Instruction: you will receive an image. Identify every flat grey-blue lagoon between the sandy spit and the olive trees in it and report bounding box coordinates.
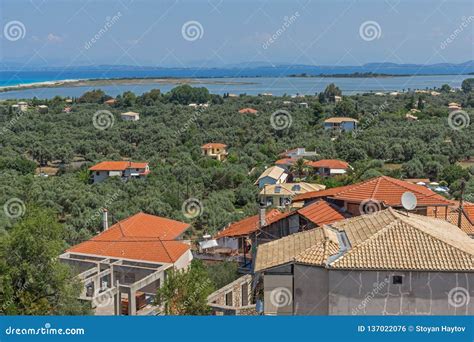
[0,75,472,99]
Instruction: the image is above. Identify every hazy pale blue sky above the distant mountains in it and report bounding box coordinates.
[0,0,474,67]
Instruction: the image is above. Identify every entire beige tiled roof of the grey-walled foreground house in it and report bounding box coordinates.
[255,208,474,272]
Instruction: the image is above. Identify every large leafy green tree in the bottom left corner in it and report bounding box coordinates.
[0,207,90,315]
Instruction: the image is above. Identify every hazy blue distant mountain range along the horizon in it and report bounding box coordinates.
[0,60,474,77]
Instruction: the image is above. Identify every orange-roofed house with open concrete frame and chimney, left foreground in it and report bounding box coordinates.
[60,210,192,315]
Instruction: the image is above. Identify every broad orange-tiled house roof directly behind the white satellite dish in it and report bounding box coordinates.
[293,176,452,218]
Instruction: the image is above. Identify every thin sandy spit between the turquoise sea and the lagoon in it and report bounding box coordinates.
[0,77,256,93]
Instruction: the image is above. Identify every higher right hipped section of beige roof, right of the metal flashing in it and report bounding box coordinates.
[330,208,474,271]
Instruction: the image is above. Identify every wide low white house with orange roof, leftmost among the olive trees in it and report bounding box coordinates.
[89,161,150,184]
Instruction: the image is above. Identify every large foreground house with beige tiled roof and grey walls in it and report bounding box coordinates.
[253,208,474,316]
